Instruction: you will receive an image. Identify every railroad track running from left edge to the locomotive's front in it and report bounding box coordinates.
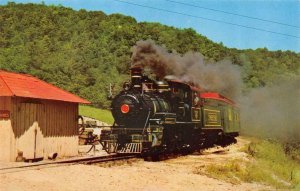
[0,155,137,174]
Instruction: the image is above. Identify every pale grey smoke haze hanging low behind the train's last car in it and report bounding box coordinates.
[240,77,300,142]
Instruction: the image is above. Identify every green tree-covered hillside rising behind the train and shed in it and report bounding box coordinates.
[0,3,300,108]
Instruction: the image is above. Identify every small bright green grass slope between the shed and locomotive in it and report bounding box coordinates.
[79,105,114,124]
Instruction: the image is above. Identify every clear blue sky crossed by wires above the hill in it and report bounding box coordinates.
[0,0,300,53]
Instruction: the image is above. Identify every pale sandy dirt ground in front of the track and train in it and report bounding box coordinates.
[0,138,273,191]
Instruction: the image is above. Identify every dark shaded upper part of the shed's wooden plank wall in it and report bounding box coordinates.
[12,98,78,137]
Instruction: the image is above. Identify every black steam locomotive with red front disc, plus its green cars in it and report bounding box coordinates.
[100,67,240,157]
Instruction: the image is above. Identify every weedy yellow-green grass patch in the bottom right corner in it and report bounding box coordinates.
[198,140,300,190]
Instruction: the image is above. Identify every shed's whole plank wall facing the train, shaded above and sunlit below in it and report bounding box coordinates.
[0,97,78,161]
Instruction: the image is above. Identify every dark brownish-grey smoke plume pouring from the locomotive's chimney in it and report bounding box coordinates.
[132,40,242,98]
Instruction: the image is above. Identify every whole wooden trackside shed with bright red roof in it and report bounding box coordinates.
[0,70,90,162]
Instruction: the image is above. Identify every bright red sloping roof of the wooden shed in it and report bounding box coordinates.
[0,70,90,104]
